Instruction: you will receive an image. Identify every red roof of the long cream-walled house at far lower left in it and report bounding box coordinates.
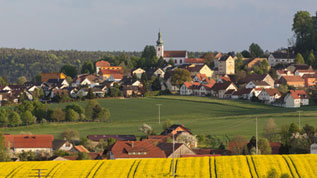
[4,135,54,149]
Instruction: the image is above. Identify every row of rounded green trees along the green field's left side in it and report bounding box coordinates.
[0,100,111,127]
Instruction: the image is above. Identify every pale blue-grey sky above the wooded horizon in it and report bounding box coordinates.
[0,0,317,52]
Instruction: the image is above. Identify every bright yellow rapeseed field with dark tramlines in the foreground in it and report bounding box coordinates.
[0,154,317,178]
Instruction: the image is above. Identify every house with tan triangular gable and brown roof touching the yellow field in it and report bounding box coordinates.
[157,143,196,158]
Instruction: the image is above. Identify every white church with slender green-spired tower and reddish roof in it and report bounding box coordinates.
[156,32,188,65]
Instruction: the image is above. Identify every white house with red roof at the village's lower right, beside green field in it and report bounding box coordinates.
[284,90,309,108]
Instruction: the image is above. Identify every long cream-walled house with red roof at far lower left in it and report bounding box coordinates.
[4,134,54,154]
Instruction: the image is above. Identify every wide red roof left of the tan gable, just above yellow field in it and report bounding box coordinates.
[111,141,166,158]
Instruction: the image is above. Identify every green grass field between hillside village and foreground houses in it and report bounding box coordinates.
[0,96,317,137]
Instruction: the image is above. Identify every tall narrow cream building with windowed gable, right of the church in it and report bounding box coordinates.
[217,55,235,75]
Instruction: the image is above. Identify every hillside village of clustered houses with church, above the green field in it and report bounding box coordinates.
[0,33,317,108]
